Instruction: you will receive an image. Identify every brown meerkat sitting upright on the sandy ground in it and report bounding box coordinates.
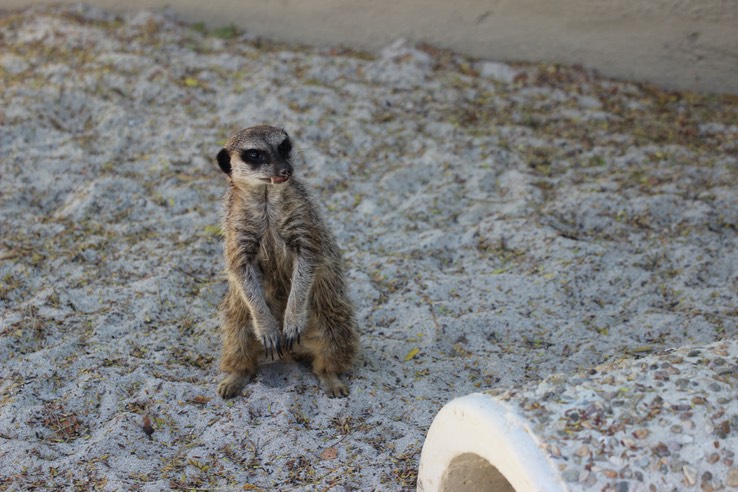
[217,125,358,398]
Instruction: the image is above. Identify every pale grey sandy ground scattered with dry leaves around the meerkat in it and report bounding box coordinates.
[0,7,738,491]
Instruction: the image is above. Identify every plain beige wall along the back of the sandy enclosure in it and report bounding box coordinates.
[0,0,738,94]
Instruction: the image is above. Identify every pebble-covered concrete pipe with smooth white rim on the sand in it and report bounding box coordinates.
[418,340,738,492]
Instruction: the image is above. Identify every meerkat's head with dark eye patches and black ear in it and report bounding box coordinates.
[217,125,292,185]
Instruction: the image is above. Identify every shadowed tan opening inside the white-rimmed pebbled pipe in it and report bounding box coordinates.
[441,453,515,492]
